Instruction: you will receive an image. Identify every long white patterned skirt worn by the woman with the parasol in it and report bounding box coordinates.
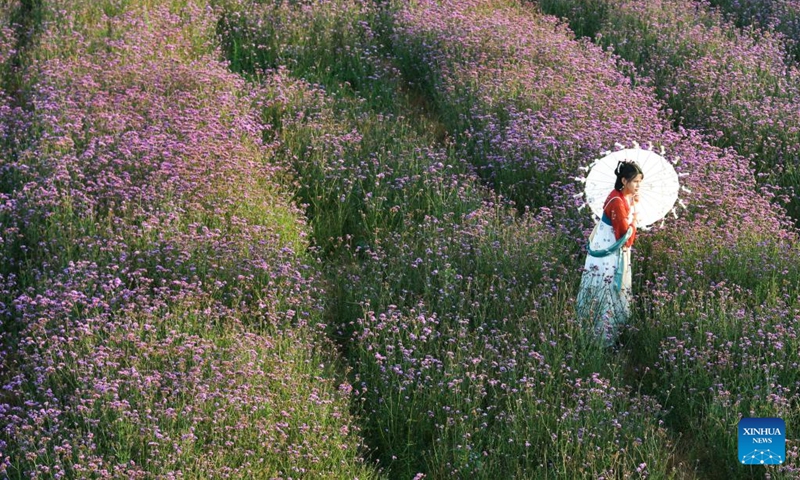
[576,221,631,346]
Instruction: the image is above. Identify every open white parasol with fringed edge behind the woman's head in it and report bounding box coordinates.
[579,144,688,228]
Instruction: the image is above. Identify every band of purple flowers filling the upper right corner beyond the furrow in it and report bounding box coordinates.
[538,0,800,219]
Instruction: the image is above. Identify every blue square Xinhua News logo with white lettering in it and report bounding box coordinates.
[739,418,786,465]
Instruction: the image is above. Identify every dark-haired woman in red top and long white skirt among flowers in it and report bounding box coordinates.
[576,161,644,346]
